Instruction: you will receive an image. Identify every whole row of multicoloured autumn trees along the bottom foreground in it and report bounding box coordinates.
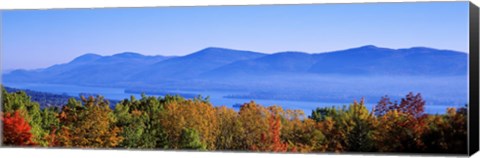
[1,88,467,154]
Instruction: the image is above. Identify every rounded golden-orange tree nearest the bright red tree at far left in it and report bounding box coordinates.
[57,96,123,148]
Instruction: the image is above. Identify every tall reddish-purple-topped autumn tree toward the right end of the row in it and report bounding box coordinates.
[375,92,428,152]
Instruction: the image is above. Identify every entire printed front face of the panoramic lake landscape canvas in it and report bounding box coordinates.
[0,2,469,154]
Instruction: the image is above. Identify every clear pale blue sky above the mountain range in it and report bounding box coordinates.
[1,2,468,70]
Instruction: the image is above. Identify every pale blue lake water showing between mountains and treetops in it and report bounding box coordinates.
[3,83,462,115]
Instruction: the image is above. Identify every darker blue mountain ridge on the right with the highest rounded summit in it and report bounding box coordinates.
[206,45,468,76]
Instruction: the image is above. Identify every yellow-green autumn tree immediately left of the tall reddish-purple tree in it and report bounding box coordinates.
[313,99,375,152]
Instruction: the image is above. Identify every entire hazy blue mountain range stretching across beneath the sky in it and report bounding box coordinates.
[3,45,468,86]
